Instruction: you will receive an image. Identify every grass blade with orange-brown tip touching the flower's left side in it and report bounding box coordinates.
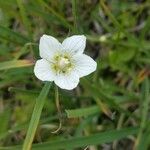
[0,59,33,70]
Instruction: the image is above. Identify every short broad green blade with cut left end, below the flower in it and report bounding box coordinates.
[66,106,100,118]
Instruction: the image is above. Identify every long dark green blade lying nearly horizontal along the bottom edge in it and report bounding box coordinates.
[0,128,138,150]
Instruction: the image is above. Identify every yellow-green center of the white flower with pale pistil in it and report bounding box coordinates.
[52,54,73,73]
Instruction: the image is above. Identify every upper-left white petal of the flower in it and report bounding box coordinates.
[39,34,61,61]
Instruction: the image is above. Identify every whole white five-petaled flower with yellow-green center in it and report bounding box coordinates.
[34,35,97,90]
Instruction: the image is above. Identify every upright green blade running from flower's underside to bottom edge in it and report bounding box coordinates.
[23,82,51,150]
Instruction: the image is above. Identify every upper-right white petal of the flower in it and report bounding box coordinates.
[62,35,86,54]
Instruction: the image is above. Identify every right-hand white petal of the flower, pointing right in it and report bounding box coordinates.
[74,54,97,77]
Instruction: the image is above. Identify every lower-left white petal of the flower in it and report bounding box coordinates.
[34,59,55,81]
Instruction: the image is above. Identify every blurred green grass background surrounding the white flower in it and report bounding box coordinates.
[0,0,150,150]
